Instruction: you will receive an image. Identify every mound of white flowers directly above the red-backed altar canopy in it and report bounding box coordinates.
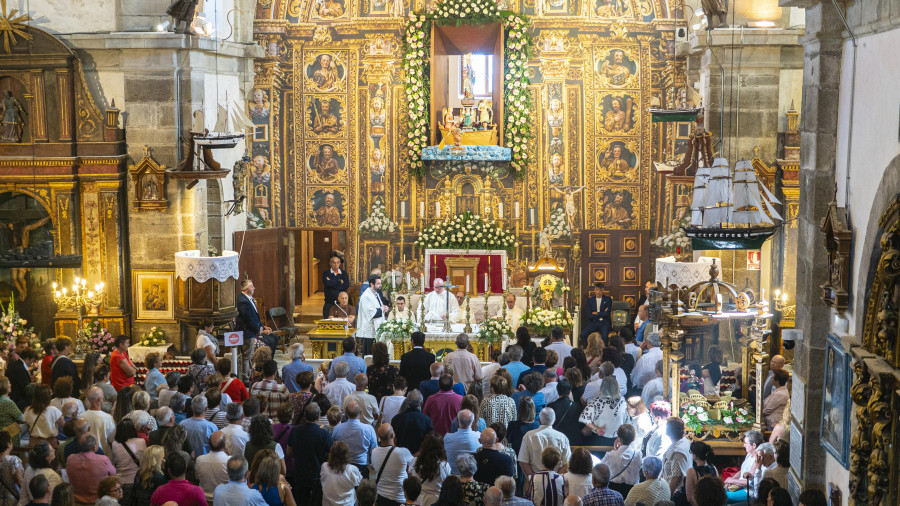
[415,213,519,251]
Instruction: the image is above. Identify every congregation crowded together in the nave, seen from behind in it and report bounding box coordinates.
[0,320,825,506]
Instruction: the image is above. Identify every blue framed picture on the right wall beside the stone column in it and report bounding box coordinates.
[820,334,851,469]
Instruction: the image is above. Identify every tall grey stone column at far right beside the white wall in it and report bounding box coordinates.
[790,2,844,500]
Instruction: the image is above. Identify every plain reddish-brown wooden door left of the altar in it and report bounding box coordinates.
[234,227,294,319]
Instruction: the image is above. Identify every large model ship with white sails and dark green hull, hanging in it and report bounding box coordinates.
[683,158,783,250]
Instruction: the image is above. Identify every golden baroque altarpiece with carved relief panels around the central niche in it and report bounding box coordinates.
[248,0,684,284]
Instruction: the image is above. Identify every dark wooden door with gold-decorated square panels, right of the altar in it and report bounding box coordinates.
[581,230,653,309]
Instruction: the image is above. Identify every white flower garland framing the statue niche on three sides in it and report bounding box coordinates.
[402,0,532,176]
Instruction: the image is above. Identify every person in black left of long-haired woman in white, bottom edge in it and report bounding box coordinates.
[287,402,332,506]
